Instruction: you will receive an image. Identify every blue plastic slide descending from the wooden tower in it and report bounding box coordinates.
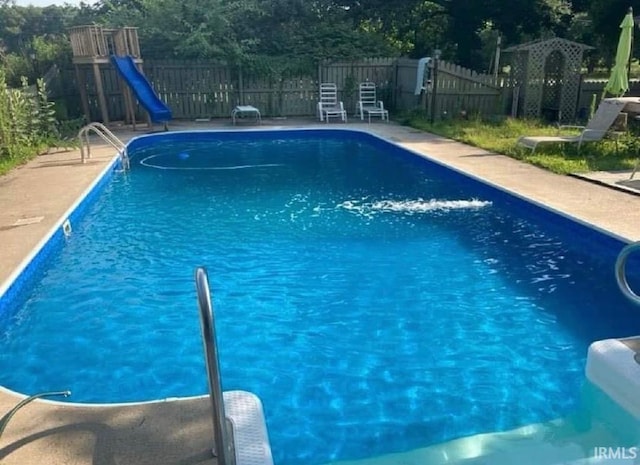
[111,55,172,123]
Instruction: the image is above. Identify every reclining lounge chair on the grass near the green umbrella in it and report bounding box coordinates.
[517,98,627,153]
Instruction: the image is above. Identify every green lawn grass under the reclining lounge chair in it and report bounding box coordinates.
[403,113,640,174]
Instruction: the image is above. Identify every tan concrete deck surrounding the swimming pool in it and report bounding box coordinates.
[0,119,640,465]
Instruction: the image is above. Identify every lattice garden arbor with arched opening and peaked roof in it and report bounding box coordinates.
[504,37,593,123]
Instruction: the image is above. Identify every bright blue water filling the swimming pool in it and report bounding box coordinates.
[0,131,640,465]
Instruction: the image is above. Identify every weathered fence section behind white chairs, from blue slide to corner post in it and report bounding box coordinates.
[149,58,394,119]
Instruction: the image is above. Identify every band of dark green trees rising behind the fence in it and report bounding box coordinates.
[0,0,640,79]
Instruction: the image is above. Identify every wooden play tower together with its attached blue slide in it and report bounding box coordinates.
[69,25,171,130]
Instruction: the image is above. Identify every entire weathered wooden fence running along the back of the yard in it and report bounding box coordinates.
[53,58,624,121]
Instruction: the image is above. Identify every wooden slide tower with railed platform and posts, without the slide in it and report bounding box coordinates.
[69,25,142,124]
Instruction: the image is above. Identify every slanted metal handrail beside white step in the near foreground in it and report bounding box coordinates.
[195,267,235,465]
